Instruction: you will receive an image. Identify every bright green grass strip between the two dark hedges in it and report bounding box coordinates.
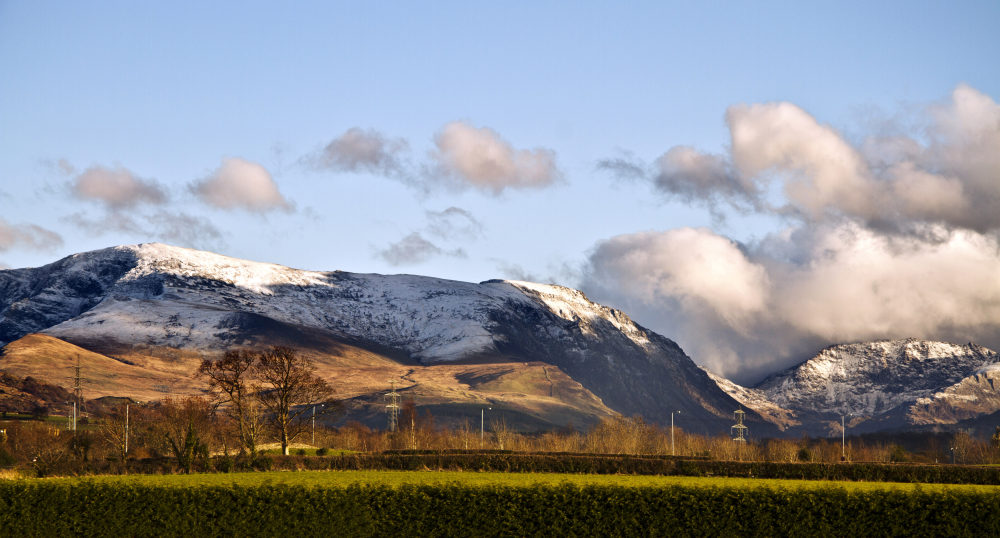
[25,471,1000,493]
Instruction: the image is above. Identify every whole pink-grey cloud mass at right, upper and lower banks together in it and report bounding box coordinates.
[583,85,1000,381]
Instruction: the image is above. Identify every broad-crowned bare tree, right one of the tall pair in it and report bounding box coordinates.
[253,347,334,456]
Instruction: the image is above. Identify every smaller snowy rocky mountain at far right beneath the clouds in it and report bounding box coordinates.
[719,339,1000,432]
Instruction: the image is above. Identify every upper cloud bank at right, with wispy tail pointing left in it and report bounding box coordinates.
[598,85,1000,232]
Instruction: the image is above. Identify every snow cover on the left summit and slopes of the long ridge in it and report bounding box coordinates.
[5,244,529,361]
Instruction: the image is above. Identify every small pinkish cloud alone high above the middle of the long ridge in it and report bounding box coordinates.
[431,122,562,194]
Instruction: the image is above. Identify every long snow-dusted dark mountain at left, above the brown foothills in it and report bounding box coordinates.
[0,244,752,432]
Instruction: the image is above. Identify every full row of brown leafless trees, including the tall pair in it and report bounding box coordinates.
[0,347,1000,474]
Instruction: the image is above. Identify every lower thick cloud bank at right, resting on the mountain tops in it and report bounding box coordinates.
[583,223,1000,382]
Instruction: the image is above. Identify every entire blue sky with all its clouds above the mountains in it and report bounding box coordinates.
[0,0,1000,383]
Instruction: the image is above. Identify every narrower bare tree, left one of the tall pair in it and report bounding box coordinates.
[198,349,264,456]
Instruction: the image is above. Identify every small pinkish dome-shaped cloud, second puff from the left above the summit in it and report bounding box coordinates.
[191,157,292,213]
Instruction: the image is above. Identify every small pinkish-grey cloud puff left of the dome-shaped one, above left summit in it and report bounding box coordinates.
[71,163,167,210]
